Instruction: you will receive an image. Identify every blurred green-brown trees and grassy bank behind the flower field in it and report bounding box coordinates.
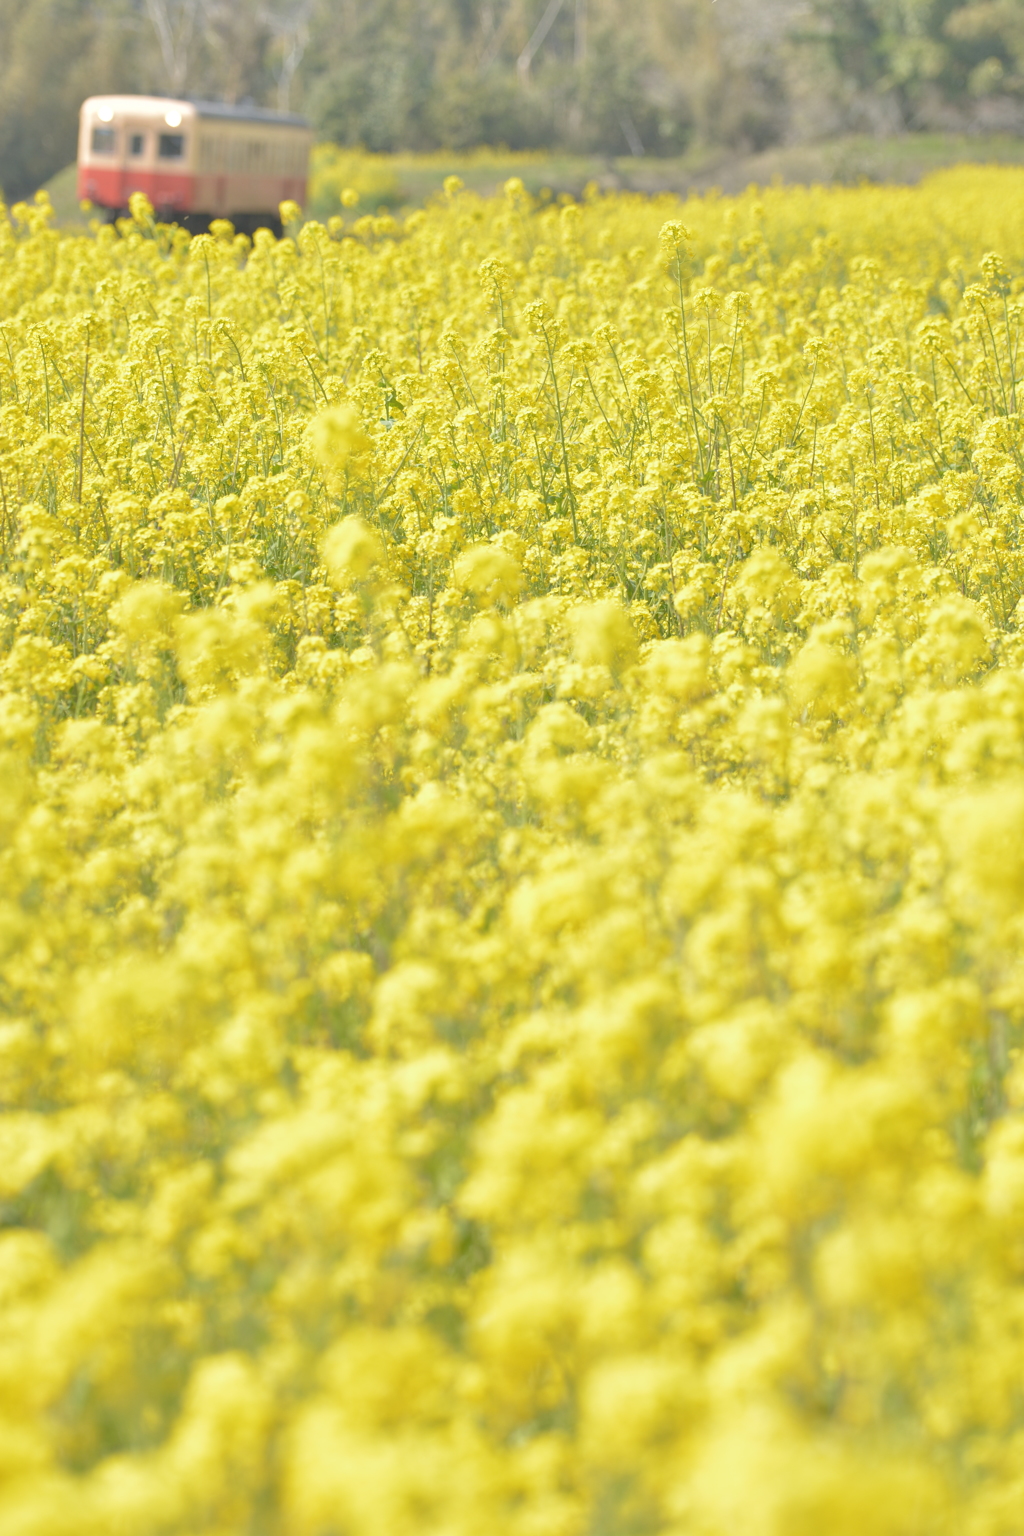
[8,0,1024,201]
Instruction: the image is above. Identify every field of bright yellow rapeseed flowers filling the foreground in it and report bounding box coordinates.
[0,169,1024,1536]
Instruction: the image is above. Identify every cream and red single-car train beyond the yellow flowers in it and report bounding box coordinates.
[78,95,313,233]
